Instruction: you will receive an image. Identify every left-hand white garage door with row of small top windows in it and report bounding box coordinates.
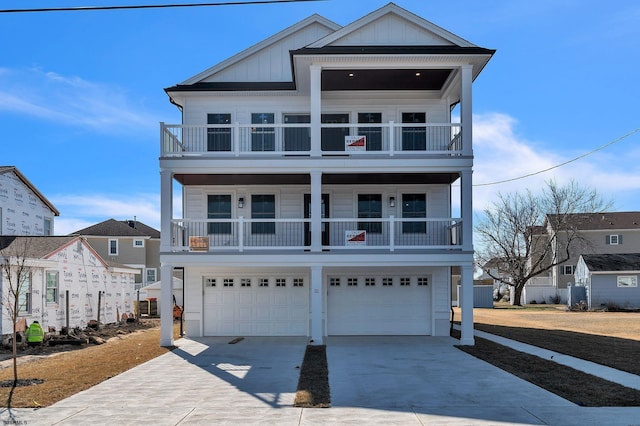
[204,277,309,336]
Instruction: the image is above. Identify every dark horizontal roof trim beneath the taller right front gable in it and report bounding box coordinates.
[291,46,496,55]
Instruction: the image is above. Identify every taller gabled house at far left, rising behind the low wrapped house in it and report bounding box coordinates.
[0,166,60,235]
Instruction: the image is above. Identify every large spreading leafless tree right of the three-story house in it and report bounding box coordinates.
[475,181,611,305]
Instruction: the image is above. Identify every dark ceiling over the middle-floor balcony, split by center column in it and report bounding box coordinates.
[174,173,460,186]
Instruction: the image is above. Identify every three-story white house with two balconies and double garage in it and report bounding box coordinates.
[160,3,494,345]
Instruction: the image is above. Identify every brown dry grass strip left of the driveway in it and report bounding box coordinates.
[0,327,177,408]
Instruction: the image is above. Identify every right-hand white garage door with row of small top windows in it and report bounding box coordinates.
[327,276,431,335]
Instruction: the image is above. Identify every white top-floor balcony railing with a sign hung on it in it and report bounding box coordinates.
[160,122,463,157]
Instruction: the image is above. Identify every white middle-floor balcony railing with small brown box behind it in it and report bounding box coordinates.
[171,216,462,252]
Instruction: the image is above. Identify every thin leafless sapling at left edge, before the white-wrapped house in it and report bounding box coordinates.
[0,236,33,386]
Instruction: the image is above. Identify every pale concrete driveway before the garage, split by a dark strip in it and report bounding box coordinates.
[0,337,640,426]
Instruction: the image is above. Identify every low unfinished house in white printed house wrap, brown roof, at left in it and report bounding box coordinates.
[0,236,139,335]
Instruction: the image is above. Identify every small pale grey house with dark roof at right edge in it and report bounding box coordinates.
[575,253,640,308]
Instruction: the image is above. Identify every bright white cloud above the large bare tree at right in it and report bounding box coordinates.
[473,113,640,211]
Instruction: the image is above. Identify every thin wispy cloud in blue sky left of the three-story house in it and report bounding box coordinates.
[0,68,161,133]
